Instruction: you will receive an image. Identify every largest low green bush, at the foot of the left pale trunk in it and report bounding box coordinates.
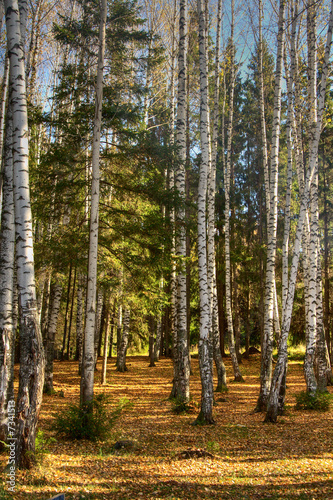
[55,394,129,441]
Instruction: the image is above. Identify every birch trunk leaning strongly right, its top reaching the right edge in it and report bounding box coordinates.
[265,1,333,422]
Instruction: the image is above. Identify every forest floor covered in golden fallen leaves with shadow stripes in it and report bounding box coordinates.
[0,355,333,500]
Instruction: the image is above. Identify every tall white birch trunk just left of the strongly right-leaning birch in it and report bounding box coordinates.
[256,0,285,411]
